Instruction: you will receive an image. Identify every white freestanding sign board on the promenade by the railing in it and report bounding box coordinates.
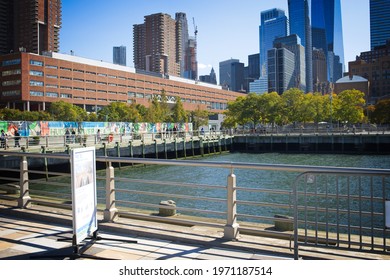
[71,147,97,245]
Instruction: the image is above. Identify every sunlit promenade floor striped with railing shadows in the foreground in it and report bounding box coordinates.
[0,201,390,260]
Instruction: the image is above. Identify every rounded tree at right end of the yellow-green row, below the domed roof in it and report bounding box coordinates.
[334,89,366,123]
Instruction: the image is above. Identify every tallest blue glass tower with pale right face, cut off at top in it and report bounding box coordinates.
[311,0,344,83]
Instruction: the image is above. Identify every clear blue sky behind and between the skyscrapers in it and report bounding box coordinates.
[60,0,370,79]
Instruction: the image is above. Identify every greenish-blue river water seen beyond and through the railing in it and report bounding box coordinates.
[34,153,390,230]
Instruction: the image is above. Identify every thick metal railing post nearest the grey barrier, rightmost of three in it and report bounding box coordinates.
[223,170,239,240]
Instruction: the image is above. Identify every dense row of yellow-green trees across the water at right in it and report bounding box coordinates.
[223,88,390,127]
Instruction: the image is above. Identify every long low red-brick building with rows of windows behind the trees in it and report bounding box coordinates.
[0,52,242,113]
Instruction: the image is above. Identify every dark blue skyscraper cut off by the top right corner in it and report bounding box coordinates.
[370,0,390,50]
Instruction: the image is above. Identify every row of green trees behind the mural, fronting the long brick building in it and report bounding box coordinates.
[0,91,209,129]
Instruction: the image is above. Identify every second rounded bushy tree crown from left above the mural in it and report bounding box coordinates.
[98,102,140,122]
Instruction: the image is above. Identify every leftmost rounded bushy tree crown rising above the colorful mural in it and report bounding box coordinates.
[49,101,88,122]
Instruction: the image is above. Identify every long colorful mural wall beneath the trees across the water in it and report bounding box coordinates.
[0,121,192,136]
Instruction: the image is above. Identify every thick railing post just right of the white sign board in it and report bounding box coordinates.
[104,162,118,222]
